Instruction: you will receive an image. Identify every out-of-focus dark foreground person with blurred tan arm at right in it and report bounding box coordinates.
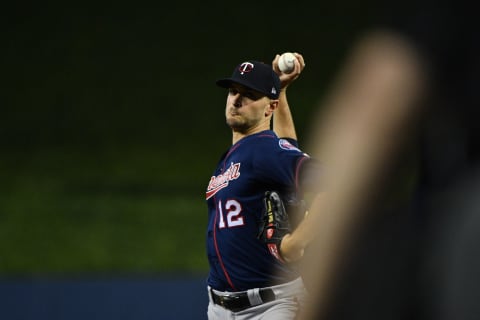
[299,1,480,320]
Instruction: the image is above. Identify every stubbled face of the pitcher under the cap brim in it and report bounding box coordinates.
[225,84,274,133]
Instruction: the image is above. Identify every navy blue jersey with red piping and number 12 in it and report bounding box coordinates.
[206,130,309,291]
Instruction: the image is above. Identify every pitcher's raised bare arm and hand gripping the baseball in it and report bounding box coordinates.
[272,52,305,140]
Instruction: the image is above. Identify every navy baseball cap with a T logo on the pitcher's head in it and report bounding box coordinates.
[216,61,280,99]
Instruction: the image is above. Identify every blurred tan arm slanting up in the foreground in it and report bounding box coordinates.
[300,32,424,319]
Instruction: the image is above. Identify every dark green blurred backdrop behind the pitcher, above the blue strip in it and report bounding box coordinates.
[0,1,378,276]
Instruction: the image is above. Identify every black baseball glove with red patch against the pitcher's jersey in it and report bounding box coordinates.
[257,191,291,262]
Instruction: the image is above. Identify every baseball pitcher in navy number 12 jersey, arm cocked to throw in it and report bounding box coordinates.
[206,53,312,320]
